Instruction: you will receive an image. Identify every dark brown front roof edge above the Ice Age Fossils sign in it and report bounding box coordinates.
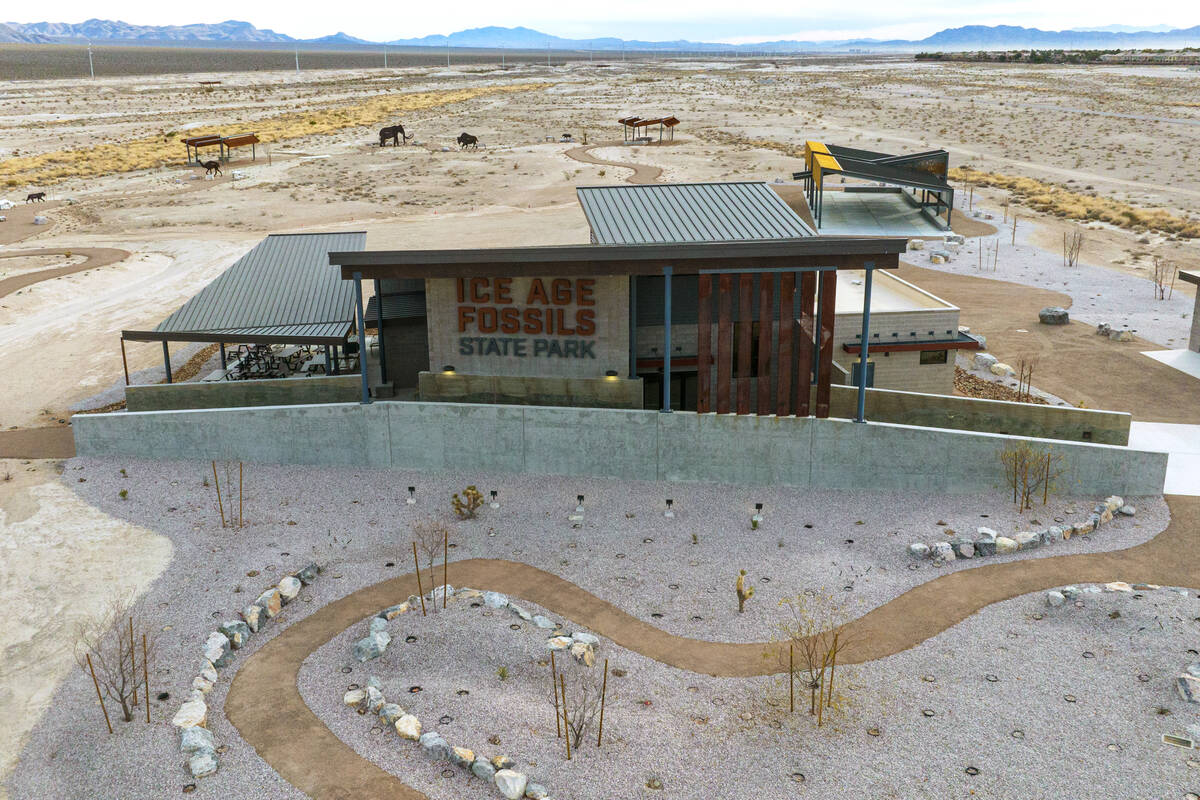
[329,236,908,279]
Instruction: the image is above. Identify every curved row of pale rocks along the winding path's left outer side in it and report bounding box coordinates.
[170,564,322,778]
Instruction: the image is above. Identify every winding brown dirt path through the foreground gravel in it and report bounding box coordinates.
[224,497,1200,800]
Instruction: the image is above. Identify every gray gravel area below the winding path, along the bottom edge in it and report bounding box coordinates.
[299,589,1200,800]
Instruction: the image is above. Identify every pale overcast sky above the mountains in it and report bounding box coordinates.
[11,0,1200,43]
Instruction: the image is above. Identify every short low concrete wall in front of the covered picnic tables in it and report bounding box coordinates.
[125,373,362,411]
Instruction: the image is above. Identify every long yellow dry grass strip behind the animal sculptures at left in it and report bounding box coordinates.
[0,83,552,186]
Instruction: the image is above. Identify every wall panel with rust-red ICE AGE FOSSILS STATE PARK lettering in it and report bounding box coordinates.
[427,277,629,377]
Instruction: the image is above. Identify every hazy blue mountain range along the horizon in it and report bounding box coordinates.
[0,19,1200,53]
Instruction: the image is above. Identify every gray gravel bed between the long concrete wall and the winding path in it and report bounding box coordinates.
[10,459,1171,800]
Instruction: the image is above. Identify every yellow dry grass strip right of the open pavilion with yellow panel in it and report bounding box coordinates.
[950,166,1200,239]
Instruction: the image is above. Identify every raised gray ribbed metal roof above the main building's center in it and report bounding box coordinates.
[575,181,815,245]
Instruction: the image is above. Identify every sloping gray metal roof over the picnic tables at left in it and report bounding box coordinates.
[122,233,366,343]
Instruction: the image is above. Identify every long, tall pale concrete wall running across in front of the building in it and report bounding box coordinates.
[72,402,1166,495]
